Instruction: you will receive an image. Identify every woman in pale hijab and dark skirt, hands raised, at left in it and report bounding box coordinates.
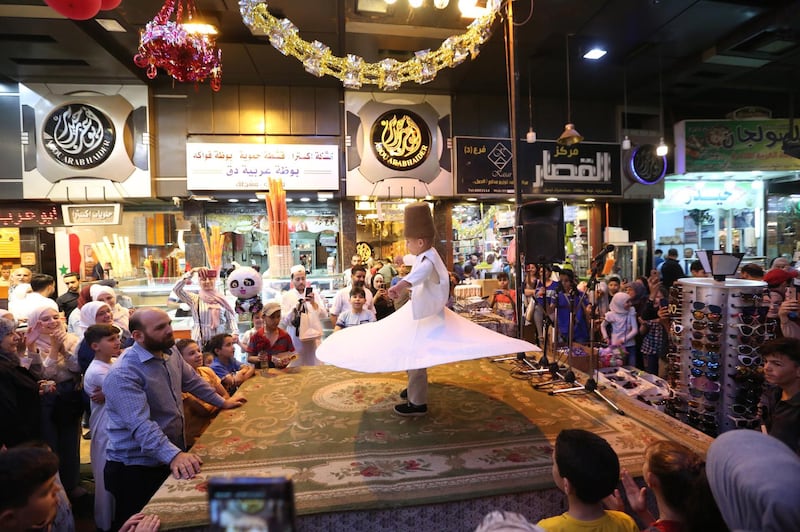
[25,306,83,498]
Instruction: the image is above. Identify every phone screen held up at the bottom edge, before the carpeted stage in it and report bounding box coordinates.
[208,477,296,532]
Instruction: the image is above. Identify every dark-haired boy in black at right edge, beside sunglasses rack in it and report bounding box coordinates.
[760,338,800,453]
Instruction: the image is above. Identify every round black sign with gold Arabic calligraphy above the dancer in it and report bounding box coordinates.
[370,109,431,170]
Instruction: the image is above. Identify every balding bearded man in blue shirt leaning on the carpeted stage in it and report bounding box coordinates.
[103,308,246,530]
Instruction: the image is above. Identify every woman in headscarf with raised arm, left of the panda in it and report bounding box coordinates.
[172,267,239,345]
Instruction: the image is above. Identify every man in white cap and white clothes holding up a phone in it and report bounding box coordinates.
[280,264,328,367]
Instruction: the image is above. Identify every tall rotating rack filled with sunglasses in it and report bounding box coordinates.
[673,278,768,436]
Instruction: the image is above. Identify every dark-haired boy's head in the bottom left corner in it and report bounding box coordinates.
[0,447,61,532]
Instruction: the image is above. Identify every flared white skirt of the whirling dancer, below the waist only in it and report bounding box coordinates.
[317,303,539,373]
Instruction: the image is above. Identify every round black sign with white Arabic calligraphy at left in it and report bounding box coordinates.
[42,103,116,170]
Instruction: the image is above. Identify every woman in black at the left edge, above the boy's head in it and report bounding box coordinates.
[0,317,43,448]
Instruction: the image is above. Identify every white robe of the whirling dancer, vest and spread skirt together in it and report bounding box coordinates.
[317,249,539,373]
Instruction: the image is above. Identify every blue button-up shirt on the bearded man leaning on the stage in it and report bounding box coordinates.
[103,343,225,467]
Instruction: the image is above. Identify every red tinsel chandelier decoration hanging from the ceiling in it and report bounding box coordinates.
[133,0,222,91]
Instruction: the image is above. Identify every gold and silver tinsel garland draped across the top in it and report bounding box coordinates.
[239,0,501,91]
